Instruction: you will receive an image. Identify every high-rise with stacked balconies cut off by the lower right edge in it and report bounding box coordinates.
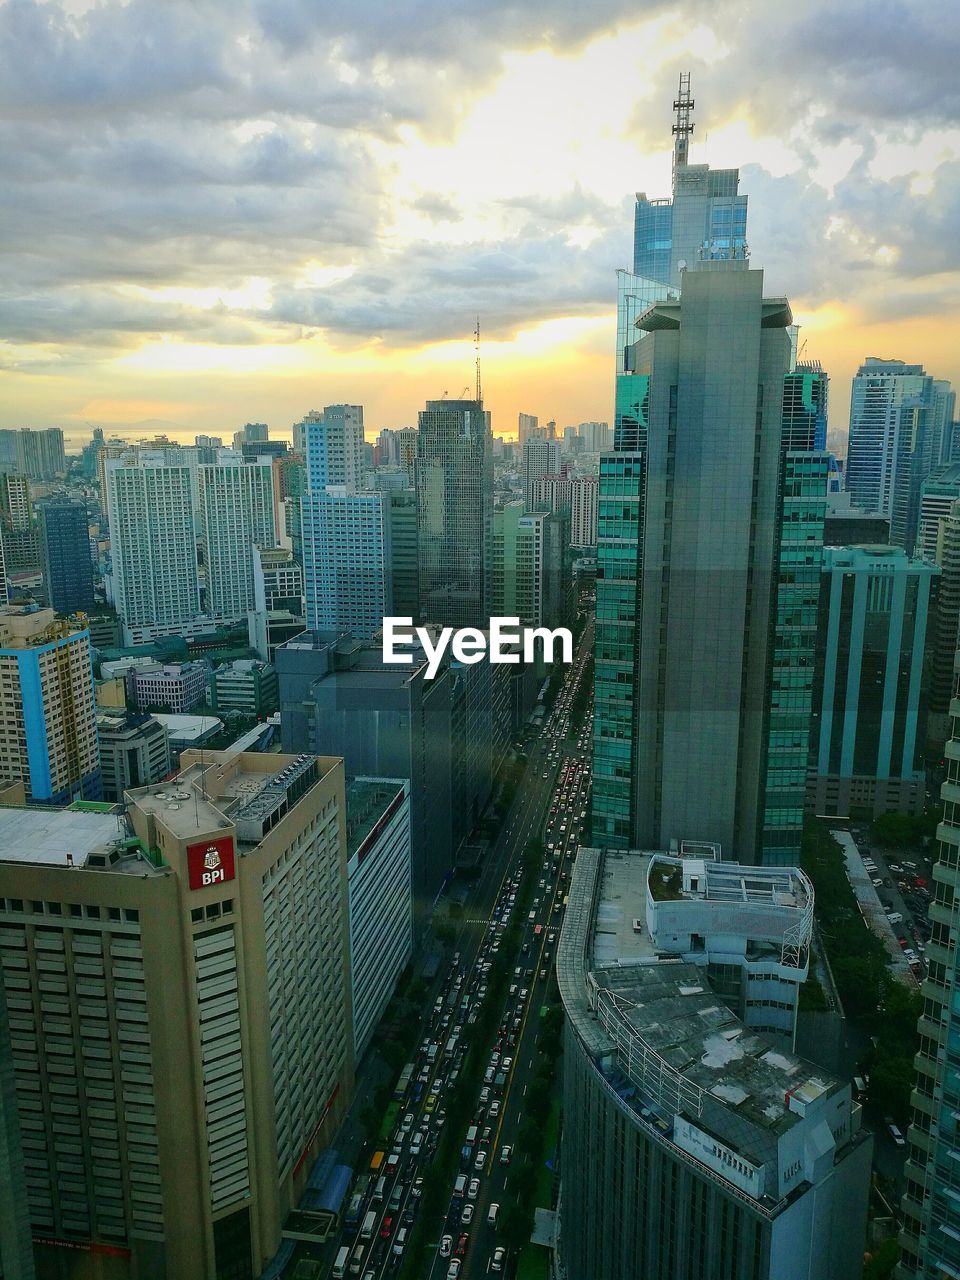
[897,650,960,1280]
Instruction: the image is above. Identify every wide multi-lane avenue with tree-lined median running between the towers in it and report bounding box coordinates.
[325,626,593,1280]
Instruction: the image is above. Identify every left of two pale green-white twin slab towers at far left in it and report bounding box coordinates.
[106,458,199,644]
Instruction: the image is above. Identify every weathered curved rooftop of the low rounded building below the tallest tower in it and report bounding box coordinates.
[557,849,841,1158]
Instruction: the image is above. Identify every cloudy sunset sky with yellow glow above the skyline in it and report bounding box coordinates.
[0,0,960,444]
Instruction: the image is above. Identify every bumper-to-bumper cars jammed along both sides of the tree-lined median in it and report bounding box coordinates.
[332,659,590,1280]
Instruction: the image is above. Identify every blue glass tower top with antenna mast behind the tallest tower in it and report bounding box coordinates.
[634,72,746,288]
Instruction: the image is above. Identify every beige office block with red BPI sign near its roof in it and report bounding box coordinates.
[0,751,353,1280]
